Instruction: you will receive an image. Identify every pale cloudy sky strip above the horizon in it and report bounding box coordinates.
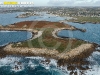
[0,0,100,6]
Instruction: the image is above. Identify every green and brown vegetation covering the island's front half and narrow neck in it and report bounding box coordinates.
[12,28,86,52]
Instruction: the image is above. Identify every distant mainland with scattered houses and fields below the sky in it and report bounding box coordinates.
[0,6,100,24]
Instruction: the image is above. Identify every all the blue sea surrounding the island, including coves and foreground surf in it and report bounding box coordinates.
[0,12,100,75]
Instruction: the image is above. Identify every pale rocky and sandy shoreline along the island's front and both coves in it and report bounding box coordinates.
[0,21,97,64]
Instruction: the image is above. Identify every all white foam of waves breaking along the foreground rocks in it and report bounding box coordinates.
[0,55,100,75]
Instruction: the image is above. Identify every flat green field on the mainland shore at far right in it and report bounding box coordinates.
[69,17,100,23]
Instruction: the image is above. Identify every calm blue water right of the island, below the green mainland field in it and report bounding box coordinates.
[58,22,100,44]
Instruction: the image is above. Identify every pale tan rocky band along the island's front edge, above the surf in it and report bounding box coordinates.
[2,44,96,64]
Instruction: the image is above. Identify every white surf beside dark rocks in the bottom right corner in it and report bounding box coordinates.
[79,51,100,75]
